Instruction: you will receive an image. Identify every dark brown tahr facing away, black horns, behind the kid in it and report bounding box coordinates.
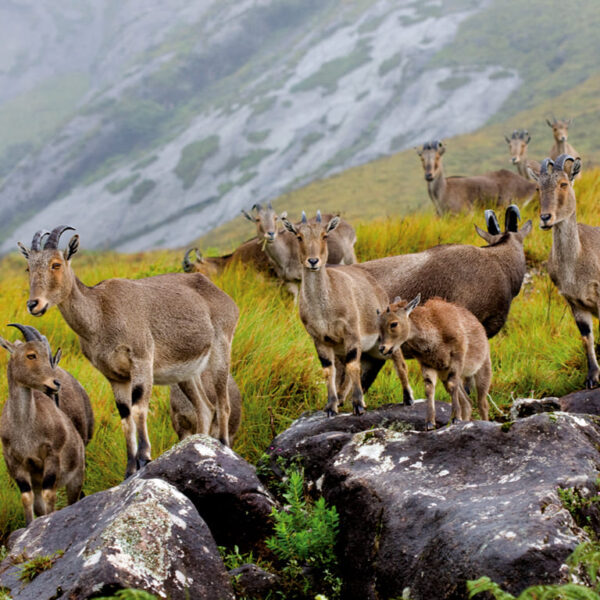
[356,205,531,397]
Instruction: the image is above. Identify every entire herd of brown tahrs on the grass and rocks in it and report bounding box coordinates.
[0,119,600,524]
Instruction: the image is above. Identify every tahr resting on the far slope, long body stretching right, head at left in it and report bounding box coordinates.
[417,140,536,215]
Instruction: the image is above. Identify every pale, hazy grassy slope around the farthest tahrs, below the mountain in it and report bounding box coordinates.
[198,75,600,251]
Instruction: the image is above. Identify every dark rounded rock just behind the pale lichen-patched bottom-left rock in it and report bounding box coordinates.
[136,434,277,550]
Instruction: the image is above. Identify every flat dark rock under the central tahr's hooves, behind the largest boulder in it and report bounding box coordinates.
[266,400,451,482]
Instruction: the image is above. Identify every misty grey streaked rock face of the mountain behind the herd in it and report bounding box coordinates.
[0,0,520,252]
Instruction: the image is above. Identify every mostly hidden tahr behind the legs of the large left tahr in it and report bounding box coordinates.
[170,371,242,443]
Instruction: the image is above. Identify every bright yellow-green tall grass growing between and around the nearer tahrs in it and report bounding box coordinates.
[0,166,600,541]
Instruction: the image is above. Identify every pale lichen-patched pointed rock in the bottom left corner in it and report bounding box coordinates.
[0,479,233,600]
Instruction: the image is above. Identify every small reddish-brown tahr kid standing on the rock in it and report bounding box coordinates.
[379,295,492,430]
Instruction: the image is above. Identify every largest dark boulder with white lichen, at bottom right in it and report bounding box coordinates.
[322,412,600,600]
